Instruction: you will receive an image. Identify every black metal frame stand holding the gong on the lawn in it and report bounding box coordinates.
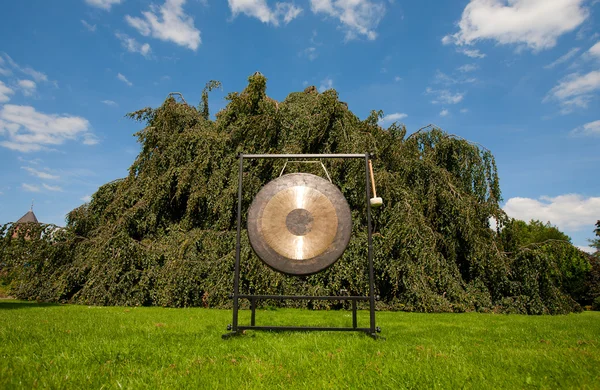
[223,153,381,338]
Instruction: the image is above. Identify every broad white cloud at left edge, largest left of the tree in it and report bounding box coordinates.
[0,104,90,152]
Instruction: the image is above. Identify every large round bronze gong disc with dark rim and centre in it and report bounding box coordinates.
[248,173,352,275]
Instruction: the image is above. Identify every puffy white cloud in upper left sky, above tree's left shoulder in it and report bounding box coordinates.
[125,0,201,51]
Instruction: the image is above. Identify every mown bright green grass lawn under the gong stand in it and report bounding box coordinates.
[0,300,600,389]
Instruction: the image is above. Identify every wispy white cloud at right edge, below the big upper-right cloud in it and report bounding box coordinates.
[543,70,600,114]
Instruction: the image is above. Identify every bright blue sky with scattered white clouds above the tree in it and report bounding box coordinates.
[0,0,600,247]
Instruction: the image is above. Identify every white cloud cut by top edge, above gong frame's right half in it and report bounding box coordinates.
[310,0,385,40]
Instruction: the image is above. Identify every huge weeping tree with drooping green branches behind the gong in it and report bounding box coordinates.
[0,73,589,314]
